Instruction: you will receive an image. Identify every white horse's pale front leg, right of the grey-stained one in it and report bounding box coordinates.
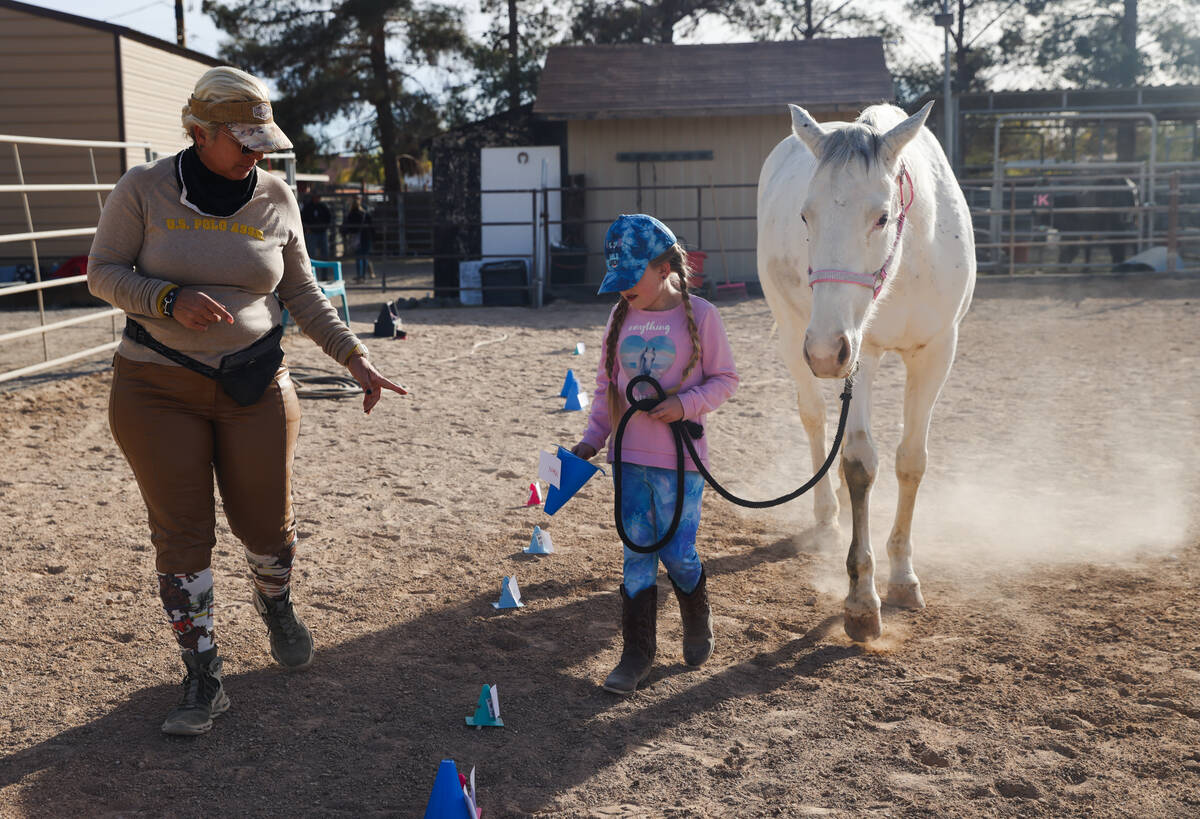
[887,329,958,609]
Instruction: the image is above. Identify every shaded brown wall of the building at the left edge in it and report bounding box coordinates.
[0,6,121,258]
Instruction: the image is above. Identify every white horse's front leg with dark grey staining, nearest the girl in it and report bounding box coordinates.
[841,351,883,642]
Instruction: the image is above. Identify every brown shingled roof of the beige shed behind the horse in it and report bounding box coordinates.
[533,37,894,119]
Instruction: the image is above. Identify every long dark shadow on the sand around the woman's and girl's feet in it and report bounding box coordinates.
[0,540,860,817]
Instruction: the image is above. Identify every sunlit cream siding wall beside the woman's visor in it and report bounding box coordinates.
[121,37,218,167]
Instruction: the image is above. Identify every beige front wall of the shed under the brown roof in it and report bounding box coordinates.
[566,111,816,282]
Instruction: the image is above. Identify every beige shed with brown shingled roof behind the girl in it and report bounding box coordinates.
[534,37,894,281]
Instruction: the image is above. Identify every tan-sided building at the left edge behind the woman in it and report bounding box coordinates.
[0,0,222,261]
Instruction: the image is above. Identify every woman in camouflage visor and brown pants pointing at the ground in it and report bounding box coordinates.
[88,66,404,735]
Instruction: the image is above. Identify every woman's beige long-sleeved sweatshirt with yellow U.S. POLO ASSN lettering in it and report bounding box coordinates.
[88,156,359,366]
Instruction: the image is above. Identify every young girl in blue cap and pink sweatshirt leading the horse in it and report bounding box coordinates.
[571,214,738,694]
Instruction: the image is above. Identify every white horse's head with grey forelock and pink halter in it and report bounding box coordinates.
[788,103,932,378]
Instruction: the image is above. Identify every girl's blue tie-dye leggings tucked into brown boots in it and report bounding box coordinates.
[620,464,704,597]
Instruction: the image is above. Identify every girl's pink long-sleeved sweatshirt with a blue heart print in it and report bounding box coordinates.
[583,295,738,471]
